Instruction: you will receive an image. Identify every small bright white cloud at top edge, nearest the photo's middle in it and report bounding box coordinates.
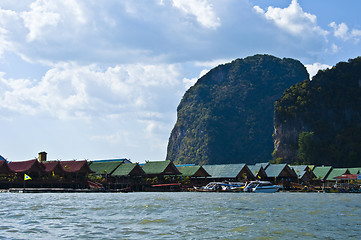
[172,0,221,29]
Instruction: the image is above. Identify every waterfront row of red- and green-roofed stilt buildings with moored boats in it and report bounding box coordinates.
[0,152,361,193]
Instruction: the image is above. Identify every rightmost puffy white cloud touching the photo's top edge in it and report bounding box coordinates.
[254,0,328,37]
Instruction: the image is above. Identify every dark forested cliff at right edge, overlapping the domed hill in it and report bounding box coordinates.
[274,57,361,167]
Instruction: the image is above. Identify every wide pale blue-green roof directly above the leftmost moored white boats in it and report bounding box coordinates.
[203,164,246,178]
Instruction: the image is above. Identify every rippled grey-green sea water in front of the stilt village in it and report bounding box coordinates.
[0,192,361,239]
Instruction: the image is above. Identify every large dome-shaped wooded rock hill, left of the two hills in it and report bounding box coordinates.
[167,55,309,164]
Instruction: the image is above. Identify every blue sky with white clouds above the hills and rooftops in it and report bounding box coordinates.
[0,0,361,162]
